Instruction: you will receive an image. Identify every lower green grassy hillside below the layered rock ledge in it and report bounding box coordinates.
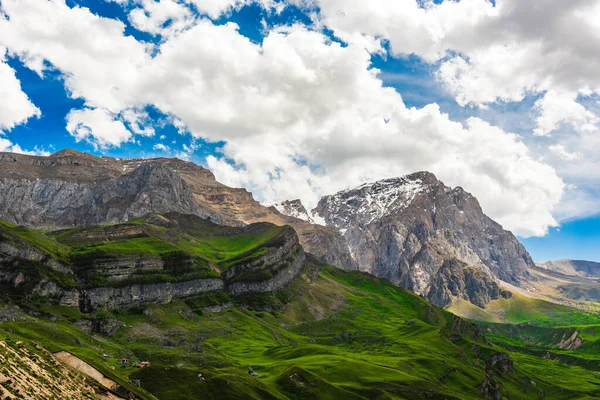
[0,267,600,399]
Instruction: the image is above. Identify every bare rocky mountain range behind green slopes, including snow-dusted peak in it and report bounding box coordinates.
[0,149,533,307]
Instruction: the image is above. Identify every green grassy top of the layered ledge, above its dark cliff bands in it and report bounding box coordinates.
[54,214,290,266]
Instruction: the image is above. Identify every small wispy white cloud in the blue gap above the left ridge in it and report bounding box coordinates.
[67,108,132,149]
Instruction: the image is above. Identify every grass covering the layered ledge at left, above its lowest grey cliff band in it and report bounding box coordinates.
[0,214,291,289]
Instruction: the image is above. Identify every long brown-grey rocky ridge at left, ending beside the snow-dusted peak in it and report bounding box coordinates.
[0,149,356,269]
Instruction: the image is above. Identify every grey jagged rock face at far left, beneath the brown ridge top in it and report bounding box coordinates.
[0,163,220,227]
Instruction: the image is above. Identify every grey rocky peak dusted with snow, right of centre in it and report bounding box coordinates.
[313,172,534,306]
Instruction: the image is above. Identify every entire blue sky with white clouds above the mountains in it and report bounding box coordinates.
[0,0,600,261]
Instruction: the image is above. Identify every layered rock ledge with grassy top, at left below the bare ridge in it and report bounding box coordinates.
[0,213,305,312]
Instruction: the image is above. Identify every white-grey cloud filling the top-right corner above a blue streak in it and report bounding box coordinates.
[316,0,600,104]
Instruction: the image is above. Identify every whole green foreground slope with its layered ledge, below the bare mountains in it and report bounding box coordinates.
[0,220,600,399]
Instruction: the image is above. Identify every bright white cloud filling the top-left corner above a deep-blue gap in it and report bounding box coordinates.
[0,0,150,113]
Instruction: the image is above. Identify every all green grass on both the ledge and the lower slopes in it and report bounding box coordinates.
[0,215,600,400]
